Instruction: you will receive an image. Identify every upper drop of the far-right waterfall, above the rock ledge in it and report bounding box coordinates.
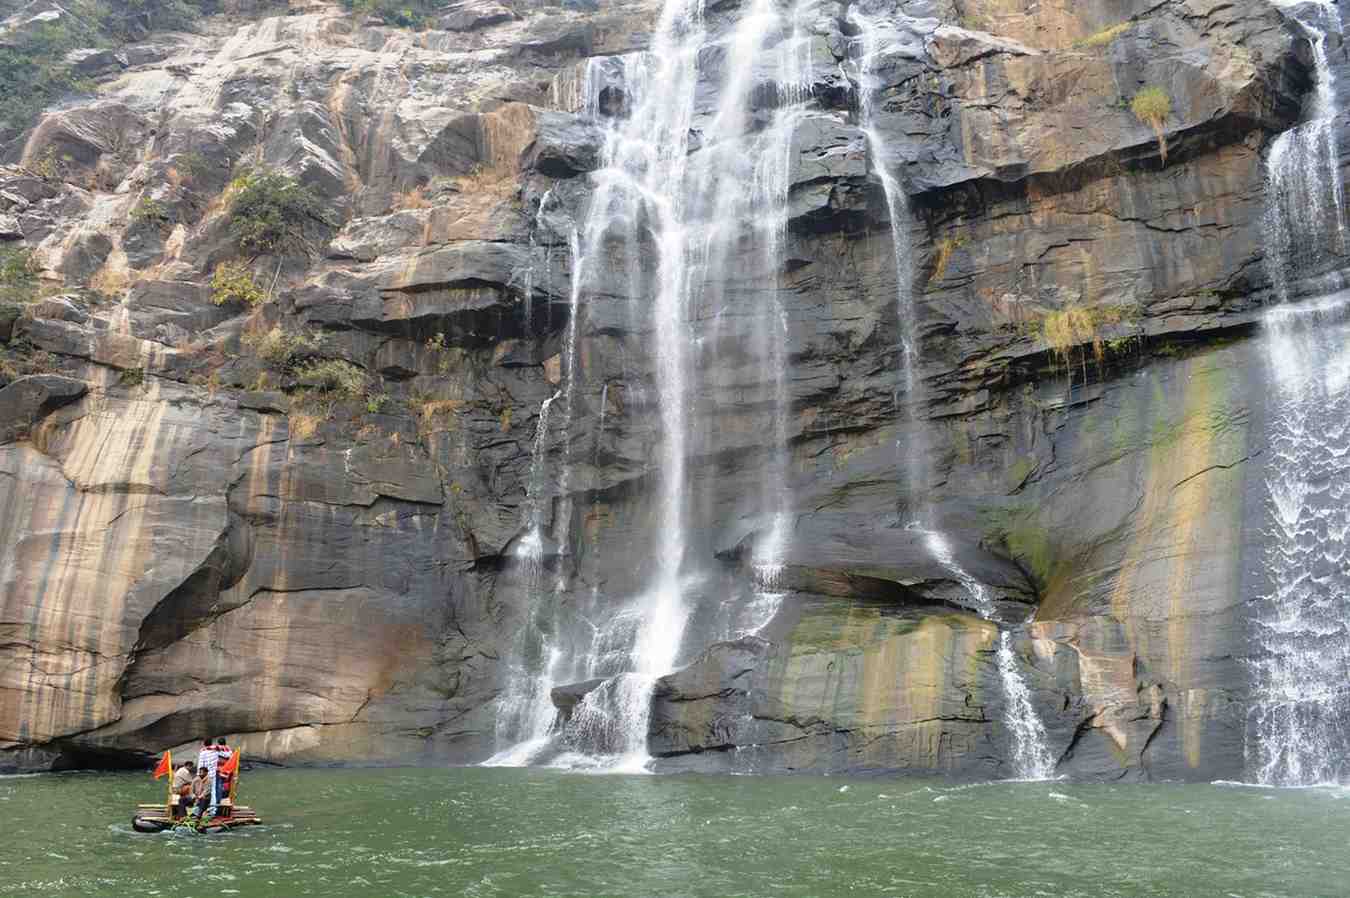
[1264,3,1346,301]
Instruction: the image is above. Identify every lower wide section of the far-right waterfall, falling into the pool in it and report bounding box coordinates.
[1246,294,1350,786]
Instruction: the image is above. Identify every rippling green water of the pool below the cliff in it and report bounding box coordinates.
[0,770,1350,898]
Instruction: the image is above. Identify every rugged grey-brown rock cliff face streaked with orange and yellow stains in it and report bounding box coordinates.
[0,0,1342,779]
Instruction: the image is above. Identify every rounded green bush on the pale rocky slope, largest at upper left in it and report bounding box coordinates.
[227,171,324,255]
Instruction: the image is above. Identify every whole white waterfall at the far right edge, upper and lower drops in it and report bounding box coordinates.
[1246,1,1350,786]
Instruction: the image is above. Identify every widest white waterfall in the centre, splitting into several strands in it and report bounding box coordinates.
[500,0,814,770]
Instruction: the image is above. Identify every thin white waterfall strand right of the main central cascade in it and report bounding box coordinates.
[849,9,1054,779]
